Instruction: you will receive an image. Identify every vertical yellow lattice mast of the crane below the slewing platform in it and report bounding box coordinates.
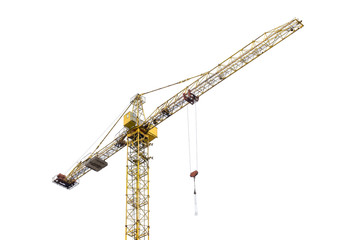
[125,128,150,240]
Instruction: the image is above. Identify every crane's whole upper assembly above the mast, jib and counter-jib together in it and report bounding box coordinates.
[53,18,303,189]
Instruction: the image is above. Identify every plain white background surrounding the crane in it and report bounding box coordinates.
[0,0,360,240]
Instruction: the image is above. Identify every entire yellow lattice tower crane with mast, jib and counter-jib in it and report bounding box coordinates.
[53,18,303,240]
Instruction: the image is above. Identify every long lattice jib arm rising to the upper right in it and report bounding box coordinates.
[142,18,303,130]
